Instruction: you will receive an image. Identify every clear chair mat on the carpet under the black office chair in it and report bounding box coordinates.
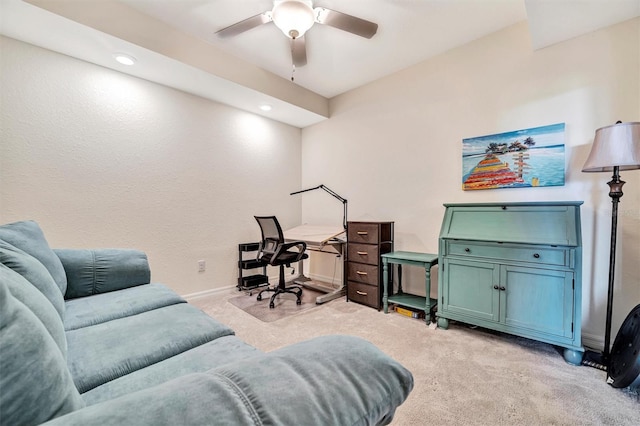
[228,289,322,322]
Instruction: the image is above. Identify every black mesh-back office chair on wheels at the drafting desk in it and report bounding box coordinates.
[254,216,309,308]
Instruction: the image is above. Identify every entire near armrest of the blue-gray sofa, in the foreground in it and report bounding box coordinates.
[46,336,413,426]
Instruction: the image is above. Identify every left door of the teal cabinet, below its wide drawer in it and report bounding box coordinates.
[440,259,500,321]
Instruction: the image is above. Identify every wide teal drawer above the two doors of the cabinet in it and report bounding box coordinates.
[447,241,569,266]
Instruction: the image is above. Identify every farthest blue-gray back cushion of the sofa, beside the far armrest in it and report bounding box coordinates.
[0,220,67,295]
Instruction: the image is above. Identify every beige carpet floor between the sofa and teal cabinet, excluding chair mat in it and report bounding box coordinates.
[191,290,640,426]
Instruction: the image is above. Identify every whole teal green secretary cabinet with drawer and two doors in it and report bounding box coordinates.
[437,202,584,365]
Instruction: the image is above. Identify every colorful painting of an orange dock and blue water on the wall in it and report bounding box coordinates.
[462,123,565,190]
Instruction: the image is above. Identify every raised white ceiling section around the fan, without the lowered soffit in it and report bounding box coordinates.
[123,0,527,98]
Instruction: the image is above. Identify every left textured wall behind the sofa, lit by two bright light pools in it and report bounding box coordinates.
[0,37,301,294]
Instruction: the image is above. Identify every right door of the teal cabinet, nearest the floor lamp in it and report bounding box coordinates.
[500,265,573,338]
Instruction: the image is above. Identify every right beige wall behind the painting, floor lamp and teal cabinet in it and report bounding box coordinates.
[302,19,640,346]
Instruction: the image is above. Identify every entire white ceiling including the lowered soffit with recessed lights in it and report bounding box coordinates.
[0,0,640,127]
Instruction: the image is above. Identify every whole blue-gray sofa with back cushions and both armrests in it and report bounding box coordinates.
[0,221,413,426]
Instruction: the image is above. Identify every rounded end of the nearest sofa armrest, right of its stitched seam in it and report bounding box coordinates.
[209,335,413,426]
